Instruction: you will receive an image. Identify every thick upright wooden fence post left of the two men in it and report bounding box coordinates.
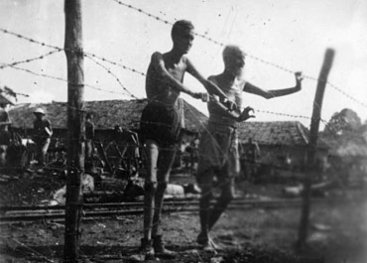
[64,0,85,262]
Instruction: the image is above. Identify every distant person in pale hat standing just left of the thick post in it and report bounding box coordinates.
[33,108,53,172]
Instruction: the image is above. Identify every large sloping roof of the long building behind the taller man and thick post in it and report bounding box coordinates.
[9,99,207,141]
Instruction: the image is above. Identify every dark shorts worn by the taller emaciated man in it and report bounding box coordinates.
[140,102,181,146]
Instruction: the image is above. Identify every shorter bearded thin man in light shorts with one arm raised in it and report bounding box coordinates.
[197,45,302,251]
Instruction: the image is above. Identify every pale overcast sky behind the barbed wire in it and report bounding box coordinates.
[0,0,367,126]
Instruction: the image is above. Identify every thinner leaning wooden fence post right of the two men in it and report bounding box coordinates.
[297,49,335,249]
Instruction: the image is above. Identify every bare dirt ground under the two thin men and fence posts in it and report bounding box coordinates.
[0,171,367,263]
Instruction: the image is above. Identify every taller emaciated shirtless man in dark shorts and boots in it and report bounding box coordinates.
[139,20,234,259]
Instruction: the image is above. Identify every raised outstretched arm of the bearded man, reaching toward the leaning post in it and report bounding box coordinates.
[243,72,303,99]
